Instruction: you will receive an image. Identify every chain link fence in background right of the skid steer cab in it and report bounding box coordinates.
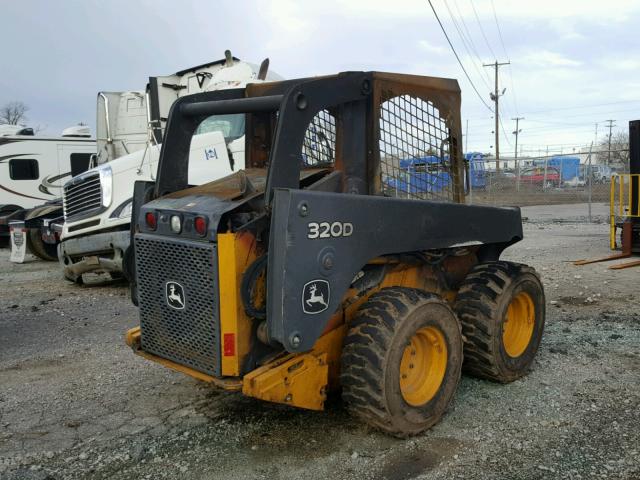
[466,151,629,212]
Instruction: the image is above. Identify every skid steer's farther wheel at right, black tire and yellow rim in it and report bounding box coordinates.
[455,261,545,383]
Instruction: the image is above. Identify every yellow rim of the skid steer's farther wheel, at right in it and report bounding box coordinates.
[502,292,536,357]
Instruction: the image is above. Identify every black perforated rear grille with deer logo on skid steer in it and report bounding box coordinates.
[135,234,220,376]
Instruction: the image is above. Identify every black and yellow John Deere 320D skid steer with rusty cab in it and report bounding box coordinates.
[127,72,545,436]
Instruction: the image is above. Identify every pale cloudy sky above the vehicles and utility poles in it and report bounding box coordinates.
[0,0,640,156]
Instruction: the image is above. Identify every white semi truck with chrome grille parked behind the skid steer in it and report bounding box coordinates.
[58,52,280,282]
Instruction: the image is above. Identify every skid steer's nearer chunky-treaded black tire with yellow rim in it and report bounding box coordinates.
[340,287,462,438]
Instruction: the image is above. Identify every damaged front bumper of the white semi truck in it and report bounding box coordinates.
[58,230,130,281]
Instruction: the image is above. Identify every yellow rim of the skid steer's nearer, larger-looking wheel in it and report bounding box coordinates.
[400,327,447,407]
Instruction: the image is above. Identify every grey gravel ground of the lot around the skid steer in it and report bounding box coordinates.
[0,205,640,480]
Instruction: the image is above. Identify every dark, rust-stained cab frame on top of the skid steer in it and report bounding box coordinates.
[153,72,464,207]
